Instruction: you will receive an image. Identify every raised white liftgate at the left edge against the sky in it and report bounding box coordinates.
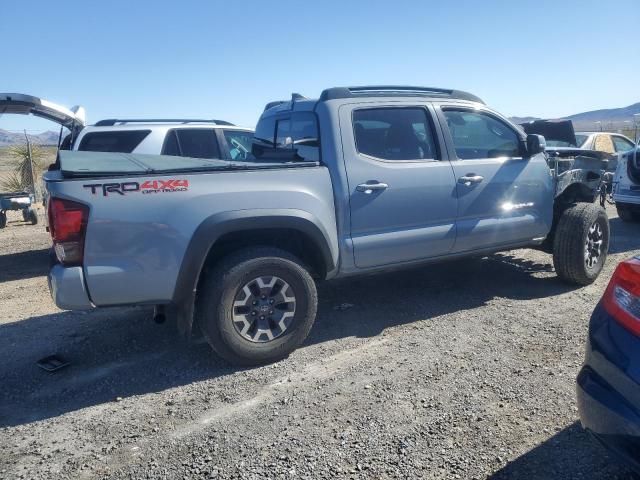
[0,93,86,130]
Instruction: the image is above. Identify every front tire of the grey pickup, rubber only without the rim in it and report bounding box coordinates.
[553,203,609,285]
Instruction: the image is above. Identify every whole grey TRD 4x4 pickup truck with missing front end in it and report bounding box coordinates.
[45,87,609,365]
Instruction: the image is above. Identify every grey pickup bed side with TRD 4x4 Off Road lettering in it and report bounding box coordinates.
[45,152,338,306]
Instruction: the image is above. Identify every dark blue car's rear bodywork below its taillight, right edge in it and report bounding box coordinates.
[577,305,640,473]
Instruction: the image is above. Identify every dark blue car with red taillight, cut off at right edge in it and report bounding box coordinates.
[577,257,640,473]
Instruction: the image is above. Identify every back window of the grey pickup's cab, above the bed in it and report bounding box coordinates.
[252,112,320,162]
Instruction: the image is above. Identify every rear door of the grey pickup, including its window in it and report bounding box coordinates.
[339,103,457,268]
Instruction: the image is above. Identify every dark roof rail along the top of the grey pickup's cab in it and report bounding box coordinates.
[320,85,484,104]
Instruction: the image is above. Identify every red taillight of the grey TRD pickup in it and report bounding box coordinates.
[48,197,89,265]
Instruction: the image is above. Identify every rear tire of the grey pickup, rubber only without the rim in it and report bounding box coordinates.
[196,247,318,366]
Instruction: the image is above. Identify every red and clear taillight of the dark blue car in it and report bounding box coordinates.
[602,257,640,336]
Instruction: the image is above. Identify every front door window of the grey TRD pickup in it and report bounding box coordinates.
[444,110,521,160]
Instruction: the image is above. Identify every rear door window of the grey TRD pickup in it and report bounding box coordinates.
[353,107,438,160]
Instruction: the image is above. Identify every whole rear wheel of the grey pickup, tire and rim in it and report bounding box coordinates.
[196,247,318,365]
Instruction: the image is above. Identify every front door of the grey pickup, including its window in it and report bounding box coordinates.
[439,106,553,253]
